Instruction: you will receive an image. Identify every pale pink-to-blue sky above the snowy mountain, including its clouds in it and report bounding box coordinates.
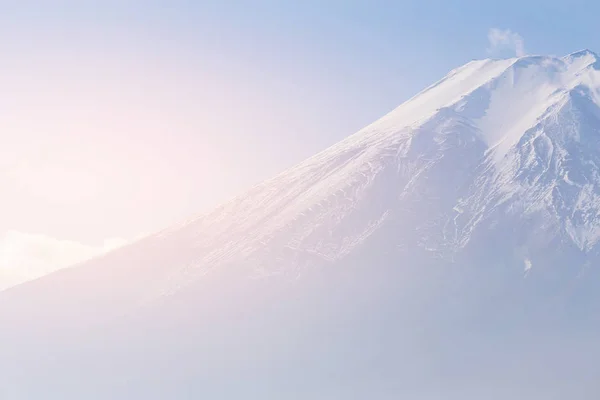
[0,0,600,289]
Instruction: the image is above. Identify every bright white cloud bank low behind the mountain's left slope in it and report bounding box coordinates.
[0,231,127,290]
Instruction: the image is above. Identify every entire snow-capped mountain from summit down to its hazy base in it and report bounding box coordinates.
[0,50,600,400]
